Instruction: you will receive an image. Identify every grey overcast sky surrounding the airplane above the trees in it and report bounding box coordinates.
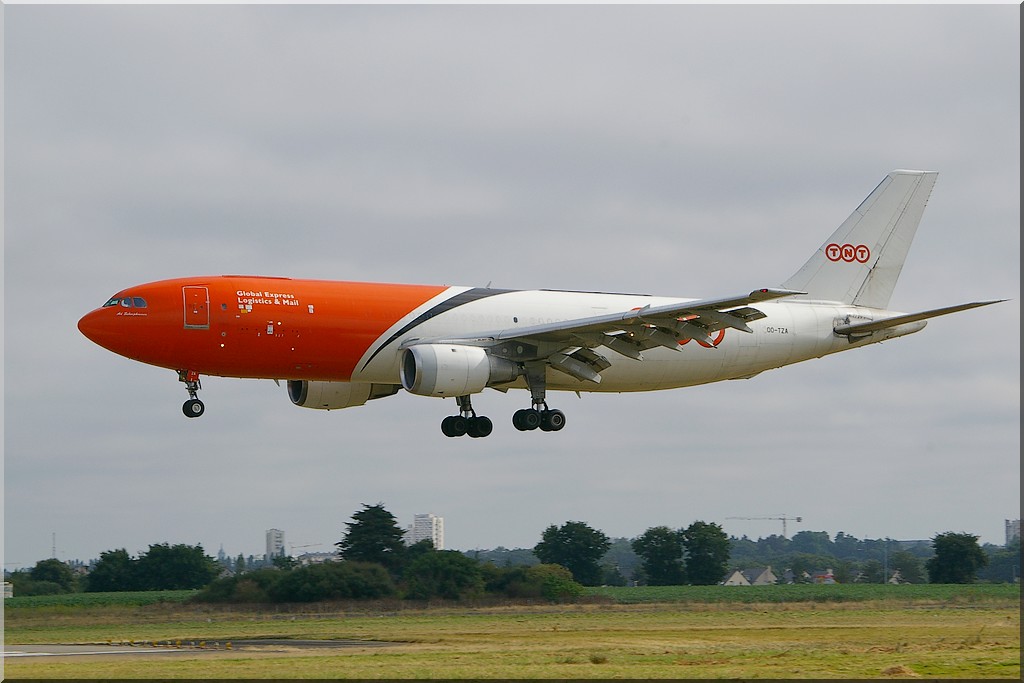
[4,4,1020,569]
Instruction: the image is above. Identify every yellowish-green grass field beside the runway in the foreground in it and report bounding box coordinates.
[5,586,1020,680]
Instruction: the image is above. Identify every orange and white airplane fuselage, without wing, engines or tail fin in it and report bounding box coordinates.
[79,275,924,392]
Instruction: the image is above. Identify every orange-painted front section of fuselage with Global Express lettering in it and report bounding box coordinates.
[79,275,447,381]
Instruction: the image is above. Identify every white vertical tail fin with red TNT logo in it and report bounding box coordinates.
[781,171,938,308]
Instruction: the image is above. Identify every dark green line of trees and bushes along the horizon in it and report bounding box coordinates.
[10,504,1020,602]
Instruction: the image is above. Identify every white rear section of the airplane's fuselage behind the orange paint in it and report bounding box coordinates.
[352,288,924,392]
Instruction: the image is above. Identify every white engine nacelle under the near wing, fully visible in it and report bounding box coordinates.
[401,344,520,396]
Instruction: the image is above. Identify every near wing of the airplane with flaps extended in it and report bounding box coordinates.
[401,288,804,383]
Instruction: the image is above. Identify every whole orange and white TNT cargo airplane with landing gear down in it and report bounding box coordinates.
[78,170,1005,438]
